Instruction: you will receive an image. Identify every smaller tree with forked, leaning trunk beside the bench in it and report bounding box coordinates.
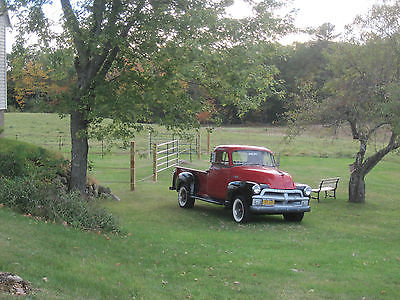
[288,1,400,203]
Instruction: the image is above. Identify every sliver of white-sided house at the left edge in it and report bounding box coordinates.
[0,0,10,136]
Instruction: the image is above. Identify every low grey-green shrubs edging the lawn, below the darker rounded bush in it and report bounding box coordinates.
[0,177,120,232]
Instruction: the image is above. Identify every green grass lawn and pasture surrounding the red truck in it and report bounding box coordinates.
[0,113,400,299]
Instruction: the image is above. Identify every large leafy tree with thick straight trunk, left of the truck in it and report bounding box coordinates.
[8,0,290,191]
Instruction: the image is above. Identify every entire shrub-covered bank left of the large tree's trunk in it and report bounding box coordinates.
[0,139,120,232]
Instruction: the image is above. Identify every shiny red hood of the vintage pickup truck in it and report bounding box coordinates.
[232,166,296,190]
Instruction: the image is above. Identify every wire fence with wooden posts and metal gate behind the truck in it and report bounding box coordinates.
[8,132,209,190]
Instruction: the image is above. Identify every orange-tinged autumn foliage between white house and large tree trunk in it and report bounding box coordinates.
[7,44,73,112]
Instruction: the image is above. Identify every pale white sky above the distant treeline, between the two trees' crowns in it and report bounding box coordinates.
[229,0,381,43]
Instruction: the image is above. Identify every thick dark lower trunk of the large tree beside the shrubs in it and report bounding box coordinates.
[69,111,89,194]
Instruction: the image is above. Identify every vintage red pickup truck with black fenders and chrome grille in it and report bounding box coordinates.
[170,145,311,223]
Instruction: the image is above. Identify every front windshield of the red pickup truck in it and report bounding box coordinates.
[232,150,275,167]
